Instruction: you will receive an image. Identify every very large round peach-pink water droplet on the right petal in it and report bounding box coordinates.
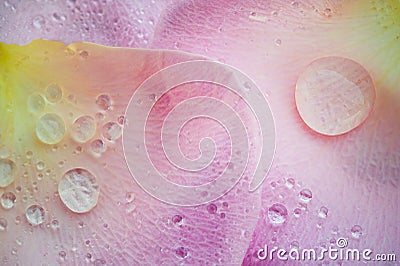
[295,57,375,136]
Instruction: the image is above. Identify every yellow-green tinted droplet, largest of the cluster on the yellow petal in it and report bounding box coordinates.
[36,113,65,144]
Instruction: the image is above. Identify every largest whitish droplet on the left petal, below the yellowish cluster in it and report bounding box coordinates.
[58,168,100,213]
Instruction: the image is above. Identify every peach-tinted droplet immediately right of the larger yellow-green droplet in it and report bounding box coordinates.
[71,115,96,143]
